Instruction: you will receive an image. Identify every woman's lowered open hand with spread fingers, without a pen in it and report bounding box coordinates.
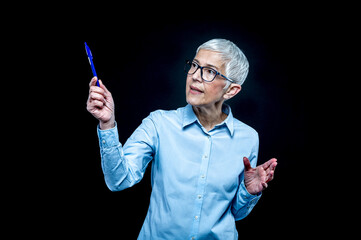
[243,157,277,195]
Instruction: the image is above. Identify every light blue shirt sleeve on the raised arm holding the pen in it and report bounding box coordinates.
[98,114,158,191]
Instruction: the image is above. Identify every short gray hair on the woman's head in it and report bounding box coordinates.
[196,38,249,85]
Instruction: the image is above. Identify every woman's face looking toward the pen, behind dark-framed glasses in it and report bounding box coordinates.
[186,49,226,107]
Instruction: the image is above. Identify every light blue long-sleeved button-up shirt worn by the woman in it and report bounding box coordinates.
[98,104,261,240]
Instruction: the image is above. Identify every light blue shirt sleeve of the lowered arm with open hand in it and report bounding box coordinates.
[232,134,262,221]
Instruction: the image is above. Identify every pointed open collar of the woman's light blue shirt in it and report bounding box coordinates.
[183,104,234,136]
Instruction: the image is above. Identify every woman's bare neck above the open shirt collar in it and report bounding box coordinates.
[193,102,227,131]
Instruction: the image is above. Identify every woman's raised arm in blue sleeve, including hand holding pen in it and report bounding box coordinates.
[87,78,157,191]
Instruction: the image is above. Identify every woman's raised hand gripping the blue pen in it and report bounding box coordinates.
[86,77,115,130]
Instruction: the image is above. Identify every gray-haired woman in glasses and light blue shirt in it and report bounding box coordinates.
[87,39,277,240]
